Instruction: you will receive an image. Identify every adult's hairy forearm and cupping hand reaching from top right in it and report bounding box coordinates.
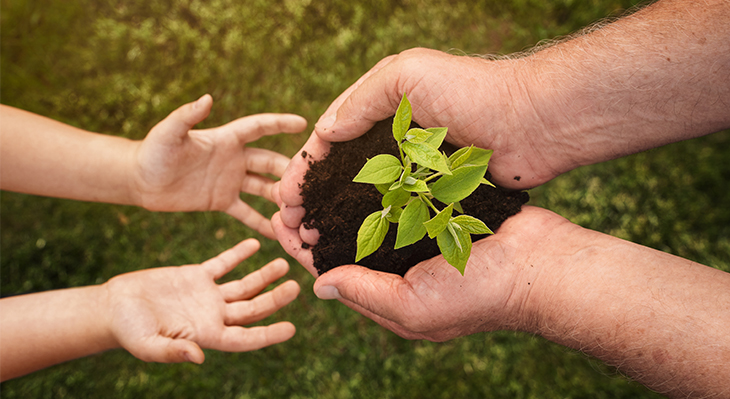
[281,0,730,223]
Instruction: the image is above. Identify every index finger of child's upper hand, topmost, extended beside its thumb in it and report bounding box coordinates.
[225,114,307,143]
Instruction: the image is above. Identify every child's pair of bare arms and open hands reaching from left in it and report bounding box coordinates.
[0,95,306,380]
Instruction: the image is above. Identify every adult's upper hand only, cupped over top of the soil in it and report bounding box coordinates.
[279,49,576,238]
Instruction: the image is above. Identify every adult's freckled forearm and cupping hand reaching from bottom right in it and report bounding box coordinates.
[290,207,730,398]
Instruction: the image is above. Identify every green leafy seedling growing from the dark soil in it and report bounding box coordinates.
[353,94,494,275]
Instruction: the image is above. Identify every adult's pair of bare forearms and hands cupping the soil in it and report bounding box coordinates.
[272,0,730,398]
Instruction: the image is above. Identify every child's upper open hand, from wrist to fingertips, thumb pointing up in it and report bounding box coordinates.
[131,94,307,238]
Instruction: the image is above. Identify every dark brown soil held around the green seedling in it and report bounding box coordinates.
[301,118,529,276]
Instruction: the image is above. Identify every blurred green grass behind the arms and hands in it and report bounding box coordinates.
[0,0,730,398]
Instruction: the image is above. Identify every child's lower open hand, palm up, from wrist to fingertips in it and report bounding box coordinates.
[105,239,299,364]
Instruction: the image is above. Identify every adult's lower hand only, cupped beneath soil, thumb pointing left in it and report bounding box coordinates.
[273,206,577,341]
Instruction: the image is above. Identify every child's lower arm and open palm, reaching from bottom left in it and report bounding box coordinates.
[0,239,299,381]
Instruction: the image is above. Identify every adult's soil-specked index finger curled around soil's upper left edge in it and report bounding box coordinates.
[279,134,330,206]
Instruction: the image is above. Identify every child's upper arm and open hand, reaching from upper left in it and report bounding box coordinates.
[0,94,307,238]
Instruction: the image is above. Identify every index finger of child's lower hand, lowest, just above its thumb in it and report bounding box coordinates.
[211,321,296,352]
